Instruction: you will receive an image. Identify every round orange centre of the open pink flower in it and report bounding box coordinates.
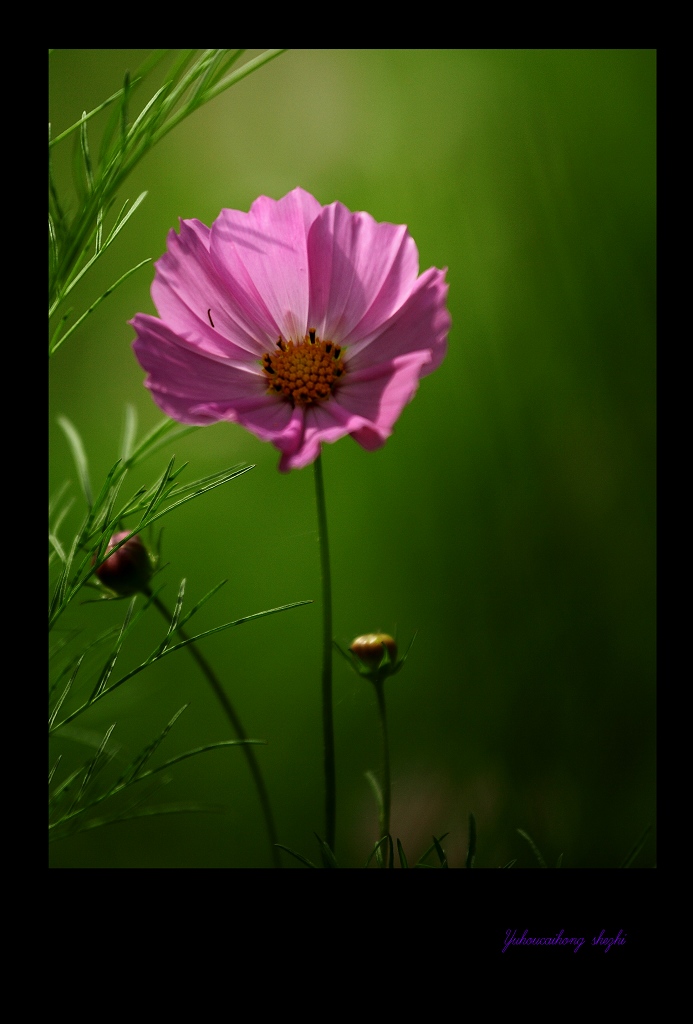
[261,329,344,406]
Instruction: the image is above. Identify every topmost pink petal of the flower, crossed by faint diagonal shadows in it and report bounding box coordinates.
[211,188,321,347]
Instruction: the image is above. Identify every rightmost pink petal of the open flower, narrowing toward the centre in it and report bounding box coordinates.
[345,267,451,381]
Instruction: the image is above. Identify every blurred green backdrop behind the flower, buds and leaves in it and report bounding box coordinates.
[49,49,656,867]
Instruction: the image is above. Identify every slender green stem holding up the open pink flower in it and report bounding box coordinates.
[313,455,337,853]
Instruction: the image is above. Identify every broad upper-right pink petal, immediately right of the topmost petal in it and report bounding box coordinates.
[308,203,419,344]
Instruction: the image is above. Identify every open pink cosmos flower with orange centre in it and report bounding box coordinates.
[130,188,450,472]
